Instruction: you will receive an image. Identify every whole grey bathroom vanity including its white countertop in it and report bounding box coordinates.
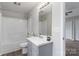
[27,37,53,56]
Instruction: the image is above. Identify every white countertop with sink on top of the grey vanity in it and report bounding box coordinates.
[26,36,53,46]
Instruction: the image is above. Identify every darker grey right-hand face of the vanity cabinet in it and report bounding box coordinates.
[39,43,53,56]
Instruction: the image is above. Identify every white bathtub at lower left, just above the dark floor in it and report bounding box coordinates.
[0,42,21,55]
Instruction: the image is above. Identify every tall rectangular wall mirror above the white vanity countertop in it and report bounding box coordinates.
[39,3,52,36]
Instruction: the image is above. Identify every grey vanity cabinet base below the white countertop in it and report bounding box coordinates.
[28,41,53,56]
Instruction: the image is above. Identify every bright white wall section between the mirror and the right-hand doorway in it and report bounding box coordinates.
[52,2,65,56]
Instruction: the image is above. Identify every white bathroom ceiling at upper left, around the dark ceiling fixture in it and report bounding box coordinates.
[0,2,39,13]
